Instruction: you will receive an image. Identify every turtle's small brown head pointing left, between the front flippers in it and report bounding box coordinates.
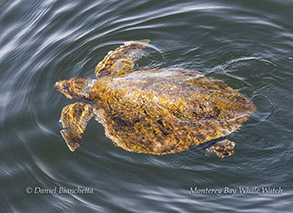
[54,78,96,99]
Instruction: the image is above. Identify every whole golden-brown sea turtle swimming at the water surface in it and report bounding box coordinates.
[55,40,255,157]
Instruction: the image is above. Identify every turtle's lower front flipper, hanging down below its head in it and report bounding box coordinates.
[60,102,93,152]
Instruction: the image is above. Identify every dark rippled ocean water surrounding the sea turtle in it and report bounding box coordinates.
[0,0,293,212]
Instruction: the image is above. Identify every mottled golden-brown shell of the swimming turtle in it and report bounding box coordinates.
[91,69,254,155]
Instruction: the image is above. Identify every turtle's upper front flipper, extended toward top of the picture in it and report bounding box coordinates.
[95,40,150,78]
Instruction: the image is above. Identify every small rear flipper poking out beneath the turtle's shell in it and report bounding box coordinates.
[206,139,235,158]
